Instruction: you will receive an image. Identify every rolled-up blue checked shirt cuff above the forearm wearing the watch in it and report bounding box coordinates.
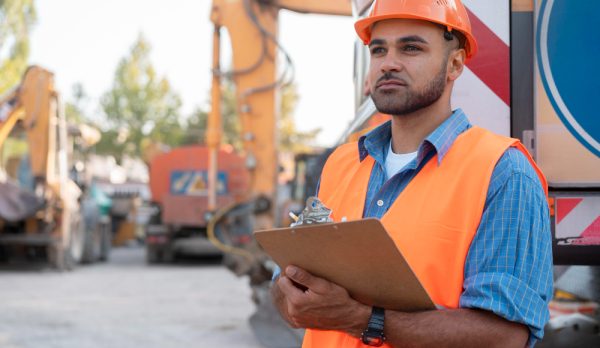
[459,273,550,347]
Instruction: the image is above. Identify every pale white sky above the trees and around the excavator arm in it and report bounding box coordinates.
[30,0,355,146]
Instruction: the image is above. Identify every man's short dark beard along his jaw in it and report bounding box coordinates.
[371,64,446,116]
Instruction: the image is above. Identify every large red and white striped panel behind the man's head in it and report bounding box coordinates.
[452,0,510,136]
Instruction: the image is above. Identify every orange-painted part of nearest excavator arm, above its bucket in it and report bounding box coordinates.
[207,0,352,228]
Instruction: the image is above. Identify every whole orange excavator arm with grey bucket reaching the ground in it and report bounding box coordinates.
[207,0,352,347]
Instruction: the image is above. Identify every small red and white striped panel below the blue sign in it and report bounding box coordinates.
[555,197,600,245]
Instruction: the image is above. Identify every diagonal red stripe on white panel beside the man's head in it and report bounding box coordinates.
[467,9,510,105]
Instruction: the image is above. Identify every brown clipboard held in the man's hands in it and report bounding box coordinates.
[254,219,435,312]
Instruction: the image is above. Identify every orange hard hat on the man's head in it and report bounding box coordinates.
[354,0,477,60]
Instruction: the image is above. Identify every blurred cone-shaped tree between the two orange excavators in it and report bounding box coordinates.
[97,34,185,158]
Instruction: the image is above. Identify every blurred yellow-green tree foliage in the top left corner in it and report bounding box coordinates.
[0,0,36,94]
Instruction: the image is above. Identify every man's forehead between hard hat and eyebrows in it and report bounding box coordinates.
[371,18,443,39]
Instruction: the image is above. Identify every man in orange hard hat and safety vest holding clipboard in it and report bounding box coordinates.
[272,0,552,348]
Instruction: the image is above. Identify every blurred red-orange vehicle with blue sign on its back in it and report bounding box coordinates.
[146,145,249,263]
